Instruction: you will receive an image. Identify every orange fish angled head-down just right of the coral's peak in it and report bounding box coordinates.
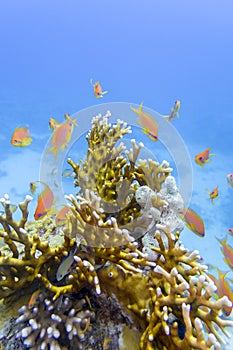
[130,103,158,141]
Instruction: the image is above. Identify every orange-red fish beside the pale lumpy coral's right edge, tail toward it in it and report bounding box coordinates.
[179,208,205,237]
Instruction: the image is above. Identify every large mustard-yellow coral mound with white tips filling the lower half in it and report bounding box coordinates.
[0,113,233,350]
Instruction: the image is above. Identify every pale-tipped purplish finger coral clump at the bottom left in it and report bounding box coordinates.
[16,294,95,350]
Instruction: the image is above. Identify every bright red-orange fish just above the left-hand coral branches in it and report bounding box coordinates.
[34,184,55,220]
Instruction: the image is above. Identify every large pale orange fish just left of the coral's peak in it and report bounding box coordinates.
[47,118,77,157]
